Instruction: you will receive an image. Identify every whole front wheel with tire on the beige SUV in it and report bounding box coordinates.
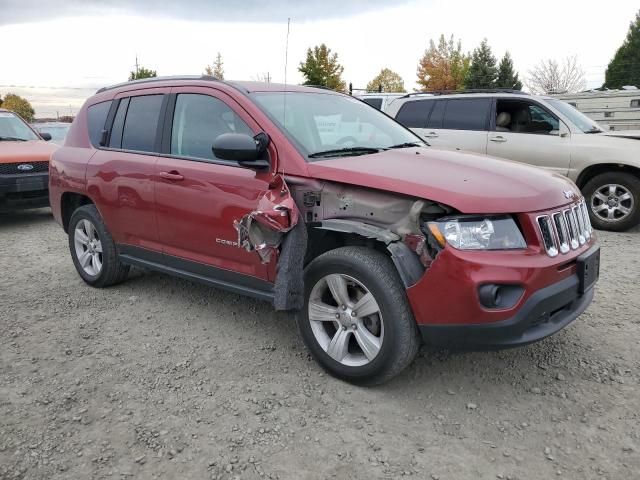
[582,172,640,232]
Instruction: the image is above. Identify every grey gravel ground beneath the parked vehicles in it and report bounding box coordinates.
[0,210,640,480]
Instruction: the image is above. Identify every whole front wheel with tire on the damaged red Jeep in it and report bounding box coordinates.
[297,247,421,385]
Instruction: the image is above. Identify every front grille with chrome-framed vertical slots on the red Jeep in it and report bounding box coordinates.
[537,200,593,257]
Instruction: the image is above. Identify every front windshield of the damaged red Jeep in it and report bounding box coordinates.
[253,92,425,161]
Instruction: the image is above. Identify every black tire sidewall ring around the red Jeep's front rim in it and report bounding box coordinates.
[297,251,408,383]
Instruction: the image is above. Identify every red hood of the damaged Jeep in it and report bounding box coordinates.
[309,147,581,214]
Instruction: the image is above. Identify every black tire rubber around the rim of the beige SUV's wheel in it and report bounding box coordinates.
[583,172,640,232]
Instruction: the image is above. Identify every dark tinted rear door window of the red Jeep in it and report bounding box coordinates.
[120,95,163,152]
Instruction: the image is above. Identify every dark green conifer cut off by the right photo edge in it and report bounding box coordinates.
[604,11,640,88]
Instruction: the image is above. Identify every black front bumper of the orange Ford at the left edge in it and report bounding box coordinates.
[0,173,49,209]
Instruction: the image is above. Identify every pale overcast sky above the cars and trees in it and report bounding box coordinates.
[0,0,639,117]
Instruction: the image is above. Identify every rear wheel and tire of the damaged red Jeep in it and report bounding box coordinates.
[69,205,129,288]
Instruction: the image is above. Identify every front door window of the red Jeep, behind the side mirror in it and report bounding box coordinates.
[171,93,253,160]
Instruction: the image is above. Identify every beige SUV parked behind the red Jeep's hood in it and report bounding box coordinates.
[386,91,640,231]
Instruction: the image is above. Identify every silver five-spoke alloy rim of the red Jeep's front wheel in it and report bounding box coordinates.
[308,273,384,367]
